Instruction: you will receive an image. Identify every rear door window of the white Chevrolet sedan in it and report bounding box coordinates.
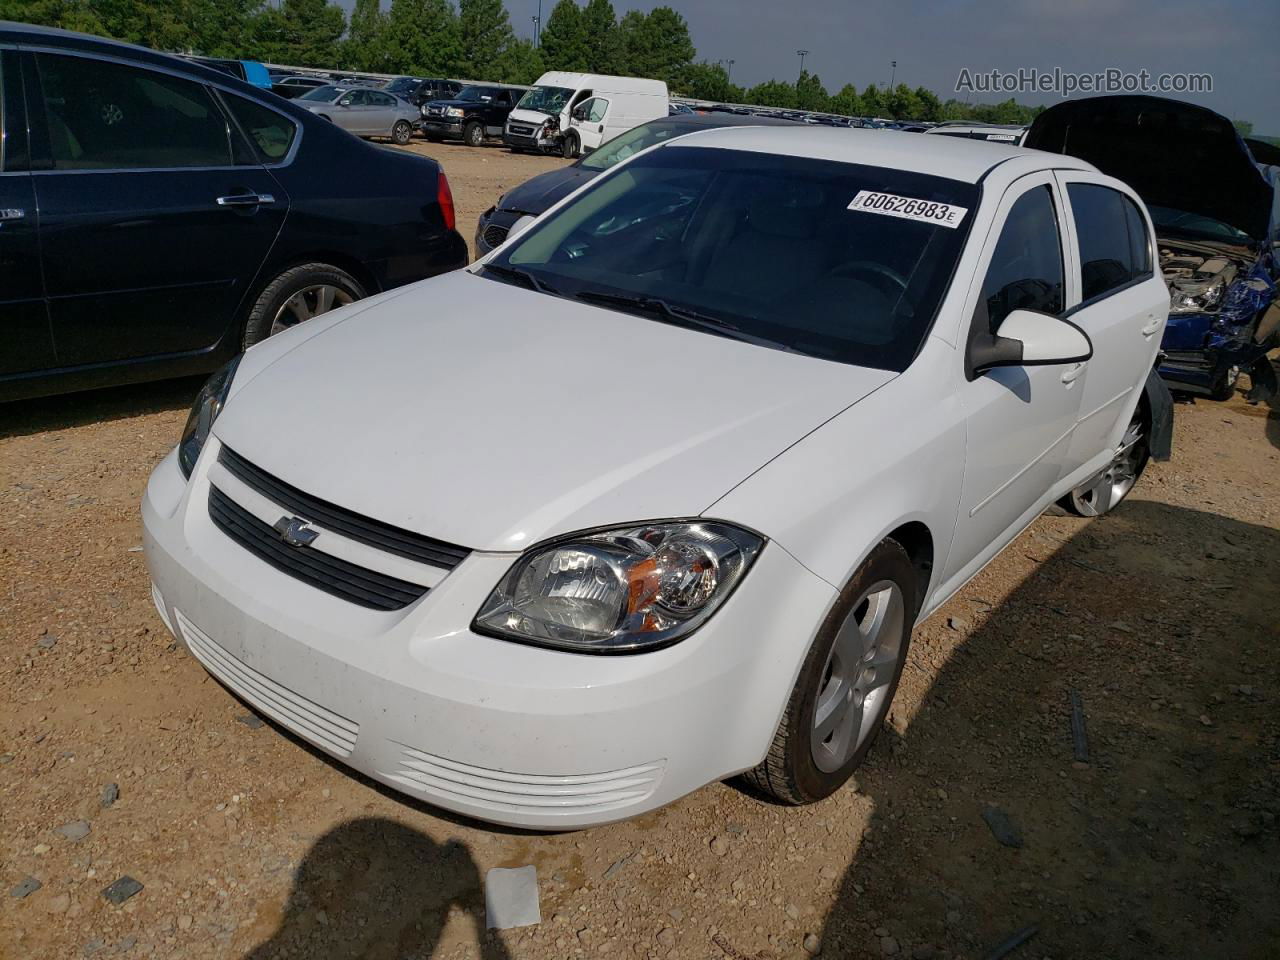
[1066,183,1151,301]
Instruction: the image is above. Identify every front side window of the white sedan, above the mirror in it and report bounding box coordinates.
[982,186,1064,333]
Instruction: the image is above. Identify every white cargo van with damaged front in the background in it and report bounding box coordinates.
[503,70,669,157]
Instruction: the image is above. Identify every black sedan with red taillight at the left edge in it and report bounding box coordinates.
[0,23,467,399]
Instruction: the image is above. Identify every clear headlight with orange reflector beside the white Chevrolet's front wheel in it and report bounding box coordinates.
[472,521,764,653]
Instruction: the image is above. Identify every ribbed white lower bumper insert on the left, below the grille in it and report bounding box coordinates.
[177,611,360,756]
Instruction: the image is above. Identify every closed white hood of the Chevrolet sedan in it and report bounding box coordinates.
[214,270,895,550]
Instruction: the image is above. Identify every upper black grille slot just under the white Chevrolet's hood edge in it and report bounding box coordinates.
[218,447,471,570]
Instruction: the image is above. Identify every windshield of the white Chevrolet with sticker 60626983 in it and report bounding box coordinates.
[492,146,978,371]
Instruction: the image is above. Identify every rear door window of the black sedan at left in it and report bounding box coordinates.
[36,54,232,170]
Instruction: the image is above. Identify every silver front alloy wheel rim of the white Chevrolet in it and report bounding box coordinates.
[809,580,906,773]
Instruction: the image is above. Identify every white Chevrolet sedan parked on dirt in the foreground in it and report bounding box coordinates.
[142,127,1169,828]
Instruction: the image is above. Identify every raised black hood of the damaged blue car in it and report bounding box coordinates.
[1023,96,1272,241]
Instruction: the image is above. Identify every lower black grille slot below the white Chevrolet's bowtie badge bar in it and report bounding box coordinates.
[209,486,428,611]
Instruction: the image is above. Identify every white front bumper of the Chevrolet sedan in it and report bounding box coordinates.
[142,438,836,829]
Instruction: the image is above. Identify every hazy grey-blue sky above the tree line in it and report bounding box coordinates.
[340,0,1280,136]
